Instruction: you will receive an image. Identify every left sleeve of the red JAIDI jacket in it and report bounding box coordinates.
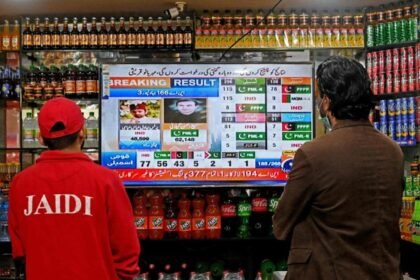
[8,177,25,259]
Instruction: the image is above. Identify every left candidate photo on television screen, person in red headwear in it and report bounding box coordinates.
[120,99,160,124]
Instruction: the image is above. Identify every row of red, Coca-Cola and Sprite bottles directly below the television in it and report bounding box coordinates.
[133,190,280,239]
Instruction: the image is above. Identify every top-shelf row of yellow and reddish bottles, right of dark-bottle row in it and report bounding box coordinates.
[195,10,364,49]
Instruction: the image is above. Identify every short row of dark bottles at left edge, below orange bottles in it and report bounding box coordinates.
[0,66,22,100]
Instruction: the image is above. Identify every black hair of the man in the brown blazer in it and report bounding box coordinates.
[316,56,374,120]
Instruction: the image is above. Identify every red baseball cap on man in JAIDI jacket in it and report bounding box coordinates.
[38,97,85,139]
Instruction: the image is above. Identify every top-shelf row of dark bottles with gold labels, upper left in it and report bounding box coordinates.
[22,17,192,50]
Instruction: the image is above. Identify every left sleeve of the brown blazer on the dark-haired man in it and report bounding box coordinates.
[273,150,313,240]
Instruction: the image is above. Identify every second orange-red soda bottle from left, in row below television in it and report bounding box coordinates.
[149,193,165,240]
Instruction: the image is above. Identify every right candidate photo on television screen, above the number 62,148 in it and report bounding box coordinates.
[164,98,207,123]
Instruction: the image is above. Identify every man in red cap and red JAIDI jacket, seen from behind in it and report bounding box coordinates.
[9,98,140,280]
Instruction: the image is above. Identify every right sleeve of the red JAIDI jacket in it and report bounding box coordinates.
[108,176,140,280]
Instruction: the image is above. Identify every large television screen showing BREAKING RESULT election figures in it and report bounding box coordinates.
[101,64,314,186]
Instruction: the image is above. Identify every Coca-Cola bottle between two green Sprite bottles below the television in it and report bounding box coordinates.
[249,190,271,237]
